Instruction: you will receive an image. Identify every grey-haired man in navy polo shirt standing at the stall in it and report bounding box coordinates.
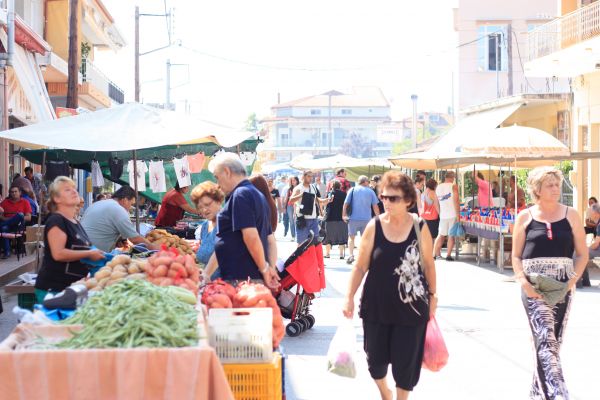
[209,153,279,288]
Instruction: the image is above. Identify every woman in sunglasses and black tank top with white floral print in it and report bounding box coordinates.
[343,171,437,399]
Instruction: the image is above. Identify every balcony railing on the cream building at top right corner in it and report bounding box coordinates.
[528,2,600,60]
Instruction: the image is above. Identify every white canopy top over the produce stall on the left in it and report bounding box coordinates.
[0,103,254,151]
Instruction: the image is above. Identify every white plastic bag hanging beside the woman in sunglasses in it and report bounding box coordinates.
[327,318,356,378]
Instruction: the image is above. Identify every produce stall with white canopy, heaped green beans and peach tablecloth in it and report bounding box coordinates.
[0,104,284,399]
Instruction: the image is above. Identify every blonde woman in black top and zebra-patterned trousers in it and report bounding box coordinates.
[512,167,588,400]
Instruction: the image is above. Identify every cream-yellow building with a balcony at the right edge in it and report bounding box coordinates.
[525,0,600,211]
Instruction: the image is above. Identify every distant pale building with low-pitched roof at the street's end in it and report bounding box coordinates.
[261,87,392,162]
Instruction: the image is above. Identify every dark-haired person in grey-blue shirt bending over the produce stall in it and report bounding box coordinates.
[81,186,159,252]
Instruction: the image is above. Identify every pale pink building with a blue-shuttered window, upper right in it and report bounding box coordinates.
[454,0,568,110]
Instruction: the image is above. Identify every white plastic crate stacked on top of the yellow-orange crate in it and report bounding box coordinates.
[208,308,273,364]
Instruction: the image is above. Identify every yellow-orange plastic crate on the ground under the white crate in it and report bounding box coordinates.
[223,353,282,400]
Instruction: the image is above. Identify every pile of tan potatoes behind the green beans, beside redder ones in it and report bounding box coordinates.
[74,254,146,292]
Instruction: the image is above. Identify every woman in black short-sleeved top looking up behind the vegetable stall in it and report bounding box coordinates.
[35,176,104,303]
